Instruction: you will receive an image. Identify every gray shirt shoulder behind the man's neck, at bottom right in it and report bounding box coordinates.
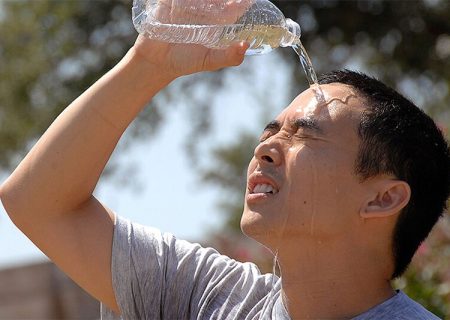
[354,290,439,320]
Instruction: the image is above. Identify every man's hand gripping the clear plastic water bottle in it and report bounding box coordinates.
[130,0,255,81]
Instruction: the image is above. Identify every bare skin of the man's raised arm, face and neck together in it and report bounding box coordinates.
[0,37,408,319]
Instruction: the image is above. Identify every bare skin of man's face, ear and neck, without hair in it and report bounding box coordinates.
[241,83,410,319]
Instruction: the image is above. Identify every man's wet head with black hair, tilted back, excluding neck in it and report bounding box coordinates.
[242,71,450,277]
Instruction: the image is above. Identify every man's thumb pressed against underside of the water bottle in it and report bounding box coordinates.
[204,41,249,71]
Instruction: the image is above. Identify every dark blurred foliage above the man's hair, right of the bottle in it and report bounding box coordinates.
[274,0,450,115]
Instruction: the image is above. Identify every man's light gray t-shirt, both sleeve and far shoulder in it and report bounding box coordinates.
[101,217,438,320]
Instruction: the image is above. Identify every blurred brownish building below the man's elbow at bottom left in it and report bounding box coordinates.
[0,262,100,320]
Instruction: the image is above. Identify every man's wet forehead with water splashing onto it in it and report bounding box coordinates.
[277,83,364,130]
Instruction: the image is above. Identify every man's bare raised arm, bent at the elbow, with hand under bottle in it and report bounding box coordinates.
[0,37,246,313]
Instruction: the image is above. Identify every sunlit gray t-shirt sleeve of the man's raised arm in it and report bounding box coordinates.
[104,217,264,319]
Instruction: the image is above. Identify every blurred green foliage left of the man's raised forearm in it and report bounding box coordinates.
[0,1,165,169]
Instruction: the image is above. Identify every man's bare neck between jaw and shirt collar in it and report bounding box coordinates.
[279,236,394,319]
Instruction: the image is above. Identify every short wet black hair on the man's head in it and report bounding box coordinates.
[319,70,450,279]
